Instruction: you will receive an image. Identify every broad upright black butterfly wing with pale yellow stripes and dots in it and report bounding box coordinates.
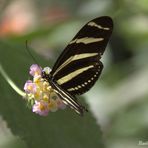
[51,16,113,95]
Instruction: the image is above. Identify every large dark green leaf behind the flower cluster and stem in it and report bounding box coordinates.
[0,41,104,148]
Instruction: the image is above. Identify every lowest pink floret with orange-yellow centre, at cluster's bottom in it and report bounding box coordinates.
[32,101,49,116]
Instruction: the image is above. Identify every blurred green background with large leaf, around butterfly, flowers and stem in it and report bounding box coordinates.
[0,0,148,148]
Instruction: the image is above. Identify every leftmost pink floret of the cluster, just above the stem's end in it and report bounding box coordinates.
[24,80,36,94]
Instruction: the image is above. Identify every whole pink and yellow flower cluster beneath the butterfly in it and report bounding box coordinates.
[24,64,66,116]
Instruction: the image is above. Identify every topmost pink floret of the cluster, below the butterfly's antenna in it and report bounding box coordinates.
[29,64,42,77]
